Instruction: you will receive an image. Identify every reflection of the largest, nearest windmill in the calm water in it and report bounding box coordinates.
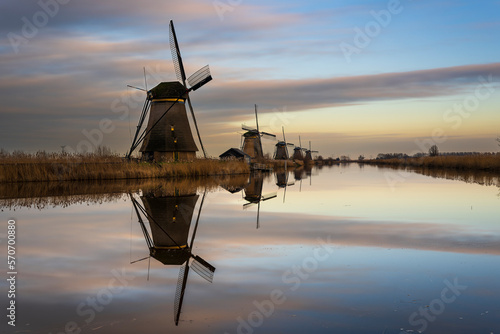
[130,188,215,325]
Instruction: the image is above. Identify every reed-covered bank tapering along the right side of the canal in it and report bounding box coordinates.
[363,154,500,172]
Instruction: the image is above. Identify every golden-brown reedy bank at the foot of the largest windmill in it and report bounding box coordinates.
[0,152,249,182]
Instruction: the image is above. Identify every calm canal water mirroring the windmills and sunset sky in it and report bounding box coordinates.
[0,164,500,334]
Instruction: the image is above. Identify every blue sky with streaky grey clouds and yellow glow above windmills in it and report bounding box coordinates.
[0,0,500,158]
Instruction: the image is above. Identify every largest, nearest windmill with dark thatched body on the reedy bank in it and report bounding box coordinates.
[127,21,212,161]
